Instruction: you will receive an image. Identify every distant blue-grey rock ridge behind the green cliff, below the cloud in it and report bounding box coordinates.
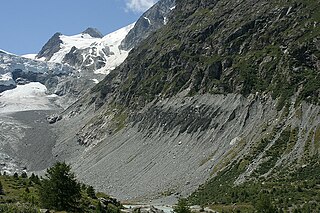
[120,0,175,50]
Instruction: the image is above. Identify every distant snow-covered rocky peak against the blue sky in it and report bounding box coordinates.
[38,24,134,74]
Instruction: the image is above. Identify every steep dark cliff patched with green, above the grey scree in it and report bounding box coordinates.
[92,0,320,111]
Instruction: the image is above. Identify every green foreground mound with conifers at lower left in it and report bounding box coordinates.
[0,163,121,213]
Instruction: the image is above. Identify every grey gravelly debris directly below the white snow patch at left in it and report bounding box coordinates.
[0,110,56,173]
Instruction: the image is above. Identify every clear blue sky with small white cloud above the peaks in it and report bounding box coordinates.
[0,0,157,55]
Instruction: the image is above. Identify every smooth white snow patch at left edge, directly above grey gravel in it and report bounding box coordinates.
[0,82,53,113]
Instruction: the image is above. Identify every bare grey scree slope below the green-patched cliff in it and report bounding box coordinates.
[59,91,320,201]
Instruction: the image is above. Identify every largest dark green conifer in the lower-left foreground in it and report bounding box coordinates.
[39,162,81,211]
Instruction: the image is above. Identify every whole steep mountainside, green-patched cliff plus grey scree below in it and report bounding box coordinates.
[48,0,320,203]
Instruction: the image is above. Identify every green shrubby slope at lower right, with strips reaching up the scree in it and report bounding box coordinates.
[188,127,320,212]
